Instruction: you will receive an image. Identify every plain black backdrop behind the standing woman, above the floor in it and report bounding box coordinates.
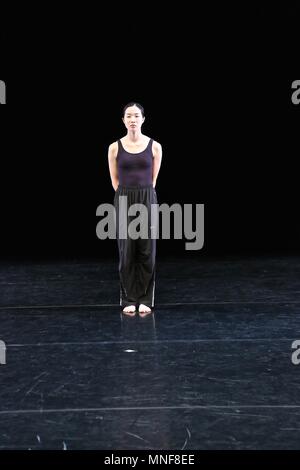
[0,4,300,260]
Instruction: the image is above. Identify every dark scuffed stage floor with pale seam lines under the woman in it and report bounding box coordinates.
[0,256,300,450]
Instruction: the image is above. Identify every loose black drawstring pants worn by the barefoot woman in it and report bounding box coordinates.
[114,185,158,308]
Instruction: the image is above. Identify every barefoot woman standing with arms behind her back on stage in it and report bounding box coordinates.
[108,102,162,316]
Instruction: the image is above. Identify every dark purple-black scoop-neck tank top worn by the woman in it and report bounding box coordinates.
[117,139,153,186]
